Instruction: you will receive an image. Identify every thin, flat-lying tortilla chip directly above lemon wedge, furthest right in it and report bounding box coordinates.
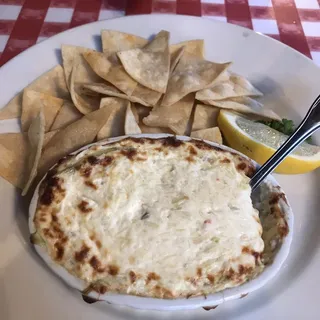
[203,97,281,120]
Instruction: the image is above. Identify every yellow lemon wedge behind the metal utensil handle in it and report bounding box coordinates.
[218,110,320,174]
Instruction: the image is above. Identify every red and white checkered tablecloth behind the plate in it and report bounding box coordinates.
[0,0,320,66]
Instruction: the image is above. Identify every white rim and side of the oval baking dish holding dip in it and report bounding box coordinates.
[29,134,293,310]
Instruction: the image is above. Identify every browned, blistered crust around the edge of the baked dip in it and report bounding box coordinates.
[34,137,288,299]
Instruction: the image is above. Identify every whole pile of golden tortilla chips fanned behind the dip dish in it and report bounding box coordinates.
[0,30,279,194]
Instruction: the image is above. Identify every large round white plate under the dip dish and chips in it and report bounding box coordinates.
[0,15,320,320]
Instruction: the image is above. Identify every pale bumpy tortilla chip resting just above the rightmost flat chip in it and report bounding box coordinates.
[196,75,263,101]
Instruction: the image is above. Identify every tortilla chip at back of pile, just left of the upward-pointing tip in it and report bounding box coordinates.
[101,30,148,55]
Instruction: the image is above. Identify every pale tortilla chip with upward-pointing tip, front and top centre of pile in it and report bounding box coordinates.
[118,31,170,93]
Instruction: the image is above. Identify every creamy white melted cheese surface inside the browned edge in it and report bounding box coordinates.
[35,139,264,297]
